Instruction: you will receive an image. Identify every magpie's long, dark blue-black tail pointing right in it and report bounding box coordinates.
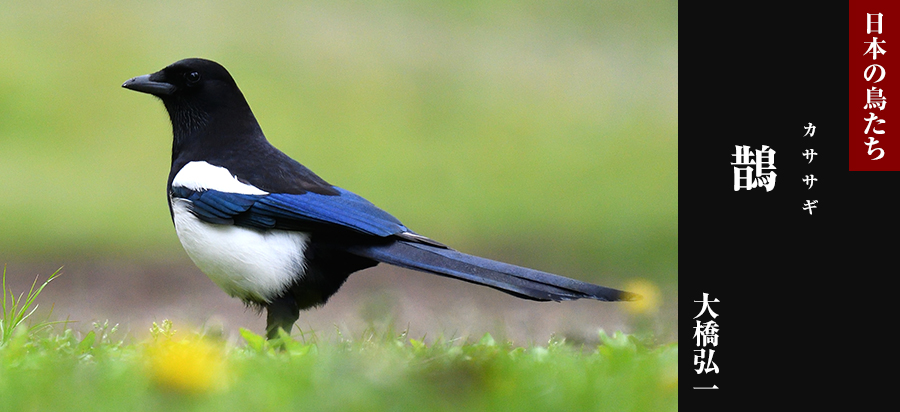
[349,240,640,301]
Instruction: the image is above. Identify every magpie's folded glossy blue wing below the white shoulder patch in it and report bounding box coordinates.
[172,187,424,238]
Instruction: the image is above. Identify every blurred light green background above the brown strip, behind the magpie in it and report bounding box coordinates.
[0,0,678,286]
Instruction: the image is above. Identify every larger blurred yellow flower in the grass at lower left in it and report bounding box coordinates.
[147,338,225,394]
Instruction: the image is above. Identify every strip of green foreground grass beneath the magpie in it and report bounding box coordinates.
[0,268,678,411]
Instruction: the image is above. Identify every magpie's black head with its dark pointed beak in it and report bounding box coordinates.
[122,58,259,150]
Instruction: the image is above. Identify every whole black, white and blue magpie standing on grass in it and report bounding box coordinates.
[122,58,639,338]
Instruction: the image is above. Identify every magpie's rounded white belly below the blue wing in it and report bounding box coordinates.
[172,198,309,302]
